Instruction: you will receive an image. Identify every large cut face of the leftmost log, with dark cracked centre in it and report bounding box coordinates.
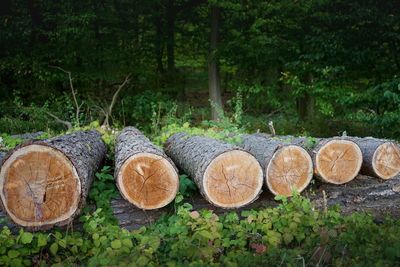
[0,145,81,227]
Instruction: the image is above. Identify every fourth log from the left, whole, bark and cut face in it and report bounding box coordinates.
[241,134,313,196]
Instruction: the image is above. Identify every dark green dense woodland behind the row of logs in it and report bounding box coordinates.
[0,0,400,137]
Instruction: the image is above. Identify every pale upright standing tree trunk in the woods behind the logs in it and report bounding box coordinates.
[208,5,223,120]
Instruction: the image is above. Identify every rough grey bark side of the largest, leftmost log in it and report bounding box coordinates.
[2,131,106,230]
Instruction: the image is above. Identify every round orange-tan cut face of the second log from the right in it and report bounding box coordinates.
[315,140,362,184]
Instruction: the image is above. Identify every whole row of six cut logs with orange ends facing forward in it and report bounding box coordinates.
[0,127,400,230]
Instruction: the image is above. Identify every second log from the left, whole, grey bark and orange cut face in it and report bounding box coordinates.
[114,127,179,210]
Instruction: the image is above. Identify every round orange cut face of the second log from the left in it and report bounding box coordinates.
[117,153,179,210]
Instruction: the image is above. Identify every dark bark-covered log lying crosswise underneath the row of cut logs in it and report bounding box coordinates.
[111,175,400,230]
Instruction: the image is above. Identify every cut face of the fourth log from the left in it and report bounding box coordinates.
[265,145,313,196]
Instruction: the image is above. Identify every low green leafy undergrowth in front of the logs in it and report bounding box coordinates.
[0,194,400,266]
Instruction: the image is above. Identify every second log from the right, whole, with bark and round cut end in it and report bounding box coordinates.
[291,137,362,184]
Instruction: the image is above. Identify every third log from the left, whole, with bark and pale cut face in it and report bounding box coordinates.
[165,133,263,208]
